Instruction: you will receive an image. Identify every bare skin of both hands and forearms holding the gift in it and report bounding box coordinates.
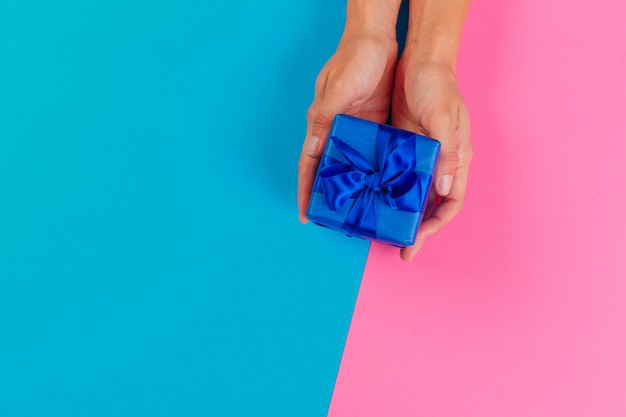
[298,0,472,261]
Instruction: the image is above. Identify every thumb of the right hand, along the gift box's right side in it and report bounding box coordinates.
[430,117,459,197]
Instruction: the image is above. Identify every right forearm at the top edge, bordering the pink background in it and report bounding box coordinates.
[406,0,471,71]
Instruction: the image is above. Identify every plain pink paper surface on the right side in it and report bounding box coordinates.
[329,0,626,417]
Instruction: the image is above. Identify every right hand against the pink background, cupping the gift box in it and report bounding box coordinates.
[391,55,473,261]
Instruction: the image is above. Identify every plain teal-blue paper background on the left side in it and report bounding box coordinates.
[0,0,368,417]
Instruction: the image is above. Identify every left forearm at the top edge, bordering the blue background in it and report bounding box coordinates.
[344,0,402,40]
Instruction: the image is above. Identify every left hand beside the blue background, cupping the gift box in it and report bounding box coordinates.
[298,34,398,223]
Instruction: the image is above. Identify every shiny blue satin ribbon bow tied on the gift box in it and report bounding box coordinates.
[320,126,430,236]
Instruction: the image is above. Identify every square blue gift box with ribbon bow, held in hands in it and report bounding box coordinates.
[307,114,441,247]
